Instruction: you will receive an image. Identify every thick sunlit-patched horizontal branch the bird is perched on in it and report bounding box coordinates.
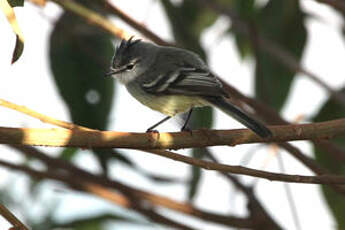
[0,118,345,149]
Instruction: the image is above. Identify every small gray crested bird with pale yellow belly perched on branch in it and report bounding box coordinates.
[107,37,272,138]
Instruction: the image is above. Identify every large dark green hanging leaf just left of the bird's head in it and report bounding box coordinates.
[49,13,114,172]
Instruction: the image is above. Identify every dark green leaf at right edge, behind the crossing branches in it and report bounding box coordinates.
[313,88,345,229]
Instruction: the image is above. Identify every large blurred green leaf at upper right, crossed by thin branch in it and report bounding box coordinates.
[255,0,307,111]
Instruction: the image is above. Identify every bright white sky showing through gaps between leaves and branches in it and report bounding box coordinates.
[0,0,345,229]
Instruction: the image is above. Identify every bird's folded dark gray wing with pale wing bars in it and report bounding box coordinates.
[141,67,228,97]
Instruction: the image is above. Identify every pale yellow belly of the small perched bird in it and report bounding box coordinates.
[127,83,207,116]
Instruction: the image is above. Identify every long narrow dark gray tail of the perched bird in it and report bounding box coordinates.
[205,97,272,138]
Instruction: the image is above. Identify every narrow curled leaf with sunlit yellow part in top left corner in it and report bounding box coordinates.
[0,0,24,64]
